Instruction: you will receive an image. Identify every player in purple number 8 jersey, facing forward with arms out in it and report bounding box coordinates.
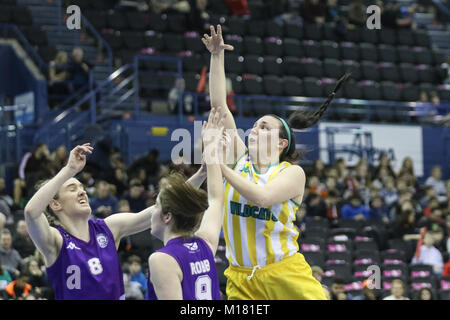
[25,143,154,300]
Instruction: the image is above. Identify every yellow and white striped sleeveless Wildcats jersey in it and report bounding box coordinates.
[223,153,299,268]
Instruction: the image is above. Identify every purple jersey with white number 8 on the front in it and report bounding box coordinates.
[47,219,125,300]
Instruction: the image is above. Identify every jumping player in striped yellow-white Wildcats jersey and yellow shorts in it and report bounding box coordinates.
[202,25,348,300]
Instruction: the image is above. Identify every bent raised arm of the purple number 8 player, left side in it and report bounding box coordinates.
[24,143,93,262]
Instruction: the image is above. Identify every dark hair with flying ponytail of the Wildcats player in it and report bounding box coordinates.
[271,73,350,163]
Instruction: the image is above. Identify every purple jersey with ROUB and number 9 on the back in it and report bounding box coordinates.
[148,237,220,300]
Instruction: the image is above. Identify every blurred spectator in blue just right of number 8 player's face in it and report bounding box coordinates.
[89,180,118,219]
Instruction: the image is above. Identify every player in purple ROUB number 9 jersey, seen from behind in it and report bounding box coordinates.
[148,112,223,300]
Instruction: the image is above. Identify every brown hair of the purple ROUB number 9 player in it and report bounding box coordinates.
[159,172,208,233]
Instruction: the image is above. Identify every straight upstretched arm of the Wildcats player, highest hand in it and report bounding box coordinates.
[202,25,246,161]
